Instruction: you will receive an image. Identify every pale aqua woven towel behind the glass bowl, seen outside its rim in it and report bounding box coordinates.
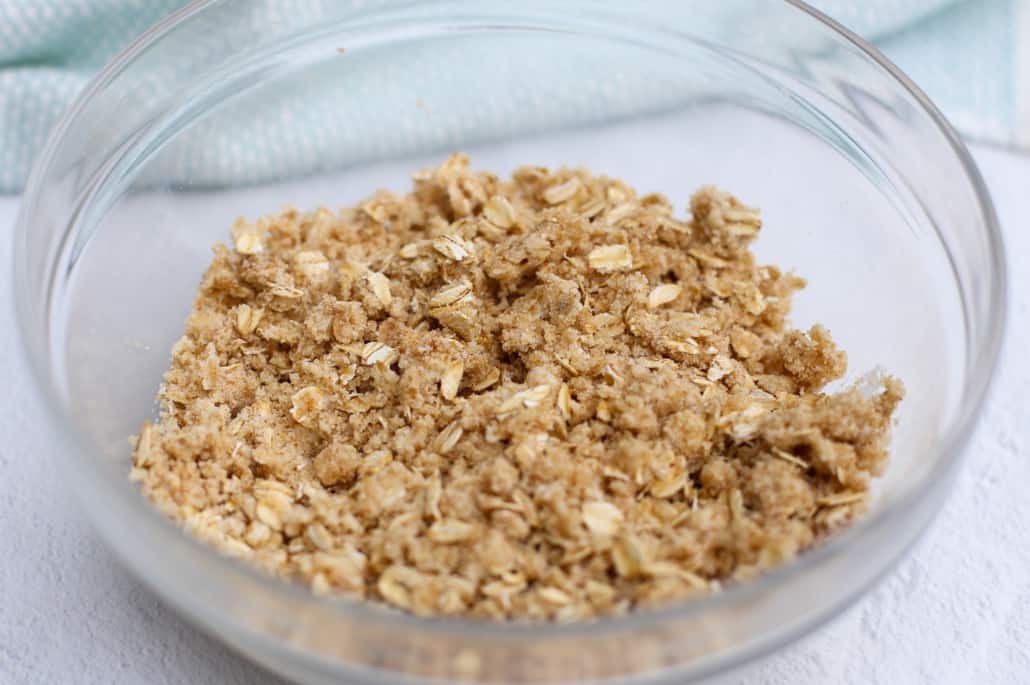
[0,0,1030,193]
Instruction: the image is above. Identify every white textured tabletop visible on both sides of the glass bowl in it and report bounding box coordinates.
[0,141,1030,685]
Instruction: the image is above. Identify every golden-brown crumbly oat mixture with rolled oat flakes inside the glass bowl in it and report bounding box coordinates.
[131,155,903,621]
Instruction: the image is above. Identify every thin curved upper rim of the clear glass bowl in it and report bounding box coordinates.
[12,0,1007,671]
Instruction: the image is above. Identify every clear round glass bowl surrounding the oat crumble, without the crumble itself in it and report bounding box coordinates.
[14,0,1004,683]
